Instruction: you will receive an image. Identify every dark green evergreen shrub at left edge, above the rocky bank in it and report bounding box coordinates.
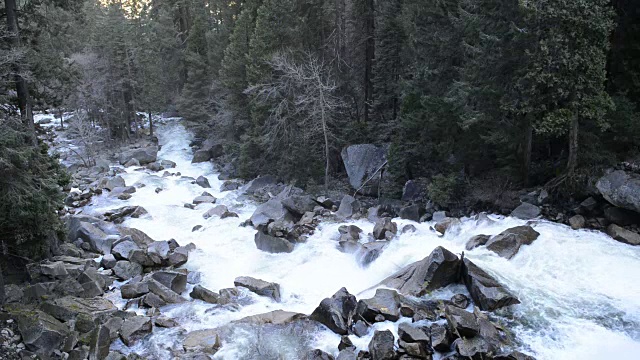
[0,118,69,259]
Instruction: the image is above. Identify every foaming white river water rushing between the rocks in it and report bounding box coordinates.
[69,119,640,360]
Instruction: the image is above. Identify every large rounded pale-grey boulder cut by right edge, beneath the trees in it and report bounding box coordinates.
[596,170,640,212]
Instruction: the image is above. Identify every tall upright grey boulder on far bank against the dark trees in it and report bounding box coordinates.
[342,144,387,195]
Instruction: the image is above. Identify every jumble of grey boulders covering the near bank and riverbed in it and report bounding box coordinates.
[0,116,633,360]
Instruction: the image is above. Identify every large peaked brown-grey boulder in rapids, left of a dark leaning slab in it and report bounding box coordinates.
[382,246,461,296]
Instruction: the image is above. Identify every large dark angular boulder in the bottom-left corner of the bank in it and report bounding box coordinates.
[6,306,70,358]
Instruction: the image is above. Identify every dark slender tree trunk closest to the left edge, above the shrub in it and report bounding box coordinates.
[4,0,38,145]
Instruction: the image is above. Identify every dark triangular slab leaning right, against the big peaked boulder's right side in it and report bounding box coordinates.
[462,259,520,311]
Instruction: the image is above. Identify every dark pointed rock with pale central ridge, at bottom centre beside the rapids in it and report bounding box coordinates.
[309,288,358,335]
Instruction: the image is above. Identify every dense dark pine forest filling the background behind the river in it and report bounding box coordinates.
[0,0,640,260]
